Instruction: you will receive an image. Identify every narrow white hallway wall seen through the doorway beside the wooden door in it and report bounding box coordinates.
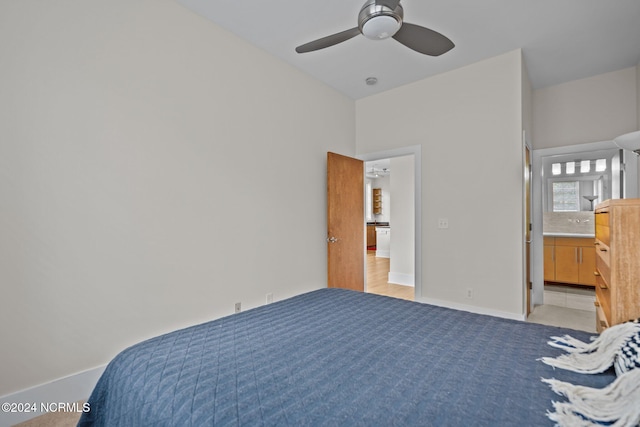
[389,156,415,285]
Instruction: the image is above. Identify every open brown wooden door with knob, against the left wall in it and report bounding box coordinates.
[327,153,365,292]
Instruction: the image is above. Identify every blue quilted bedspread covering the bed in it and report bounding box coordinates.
[78,289,615,427]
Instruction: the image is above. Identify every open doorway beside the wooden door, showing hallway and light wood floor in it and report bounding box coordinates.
[360,147,421,300]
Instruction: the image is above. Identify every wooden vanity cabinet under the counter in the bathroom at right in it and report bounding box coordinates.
[544,237,596,286]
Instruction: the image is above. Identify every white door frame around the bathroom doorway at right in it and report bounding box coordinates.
[531,141,640,307]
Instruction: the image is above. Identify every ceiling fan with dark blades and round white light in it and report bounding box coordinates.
[296,0,455,56]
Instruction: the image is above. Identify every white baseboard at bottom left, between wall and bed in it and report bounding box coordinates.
[0,365,107,426]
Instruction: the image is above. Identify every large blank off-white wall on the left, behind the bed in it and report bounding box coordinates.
[0,0,355,395]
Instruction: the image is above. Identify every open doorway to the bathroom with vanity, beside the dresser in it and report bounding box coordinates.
[529,141,638,332]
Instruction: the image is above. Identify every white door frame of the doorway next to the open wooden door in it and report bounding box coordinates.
[355,145,422,301]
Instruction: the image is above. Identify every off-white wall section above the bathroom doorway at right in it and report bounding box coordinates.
[533,67,638,149]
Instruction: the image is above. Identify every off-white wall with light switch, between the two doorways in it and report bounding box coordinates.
[356,50,523,317]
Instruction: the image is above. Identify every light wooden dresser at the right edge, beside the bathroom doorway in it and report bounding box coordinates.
[594,199,640,332]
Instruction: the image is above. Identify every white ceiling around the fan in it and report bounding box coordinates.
[178,0,640,99]
